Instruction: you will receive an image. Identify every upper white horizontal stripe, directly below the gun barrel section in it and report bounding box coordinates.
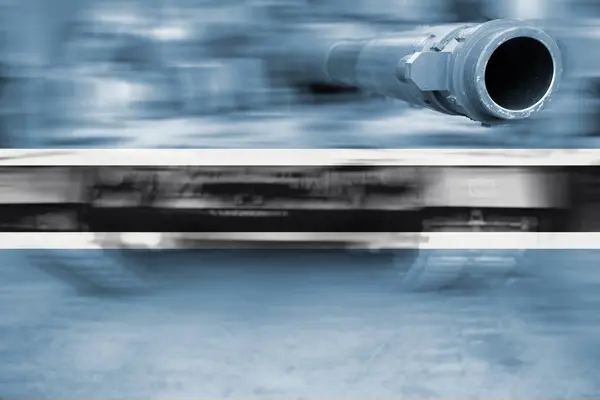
[0,149,600,166]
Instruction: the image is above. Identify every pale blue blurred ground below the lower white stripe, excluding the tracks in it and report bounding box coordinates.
[0,251,600,399]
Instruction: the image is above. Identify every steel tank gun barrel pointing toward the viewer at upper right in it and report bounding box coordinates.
[284,19,563,125]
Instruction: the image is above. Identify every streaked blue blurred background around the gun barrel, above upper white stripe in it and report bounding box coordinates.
[0,0,600,147]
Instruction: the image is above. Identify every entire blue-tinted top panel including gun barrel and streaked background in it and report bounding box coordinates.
[0,0,600,148]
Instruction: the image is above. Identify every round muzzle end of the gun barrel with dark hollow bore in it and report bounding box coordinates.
[476,29,562,120]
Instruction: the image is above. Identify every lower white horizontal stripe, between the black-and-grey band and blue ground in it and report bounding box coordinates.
[0,232,600,250]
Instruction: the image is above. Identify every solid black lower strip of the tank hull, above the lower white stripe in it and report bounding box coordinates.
[84,208,420,232]
